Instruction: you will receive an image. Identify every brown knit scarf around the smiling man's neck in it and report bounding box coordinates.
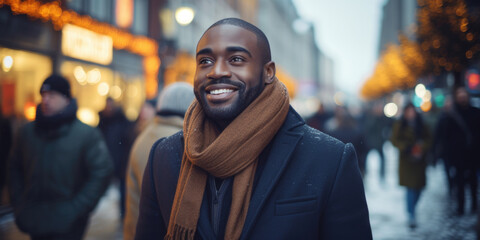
[165,79,289,239]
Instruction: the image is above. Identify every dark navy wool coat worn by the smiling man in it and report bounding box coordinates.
[136,109,372,240]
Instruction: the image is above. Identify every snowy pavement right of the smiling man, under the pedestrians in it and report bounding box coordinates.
[364,143,477,240]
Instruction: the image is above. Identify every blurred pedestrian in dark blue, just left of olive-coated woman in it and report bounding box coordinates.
[365,102,392,182]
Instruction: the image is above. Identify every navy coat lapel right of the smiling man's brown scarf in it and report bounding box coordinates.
[241,108,304,239]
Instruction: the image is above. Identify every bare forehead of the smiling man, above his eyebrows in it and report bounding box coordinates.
[197,24,257,52]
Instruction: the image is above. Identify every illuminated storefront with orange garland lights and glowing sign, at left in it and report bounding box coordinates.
[0,0,160,126]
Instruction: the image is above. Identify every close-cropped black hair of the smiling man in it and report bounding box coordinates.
[204,18,272,64]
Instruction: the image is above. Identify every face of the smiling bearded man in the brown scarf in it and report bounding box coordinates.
[194,24,264,121]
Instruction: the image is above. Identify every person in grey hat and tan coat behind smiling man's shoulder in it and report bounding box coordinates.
[123,82,195,240]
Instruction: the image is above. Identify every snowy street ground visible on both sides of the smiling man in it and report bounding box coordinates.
[0,143,477,240]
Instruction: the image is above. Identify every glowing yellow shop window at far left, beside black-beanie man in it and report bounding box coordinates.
[0,48,52,121]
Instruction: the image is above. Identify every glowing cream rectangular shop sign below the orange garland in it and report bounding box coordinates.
[62,24,113,65]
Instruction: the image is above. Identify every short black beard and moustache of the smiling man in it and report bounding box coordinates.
[195,77,264,122]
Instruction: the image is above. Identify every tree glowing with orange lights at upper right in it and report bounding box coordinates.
[360,0,480,100]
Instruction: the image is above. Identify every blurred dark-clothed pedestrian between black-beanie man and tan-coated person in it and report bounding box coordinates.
[98,97,135,220]
